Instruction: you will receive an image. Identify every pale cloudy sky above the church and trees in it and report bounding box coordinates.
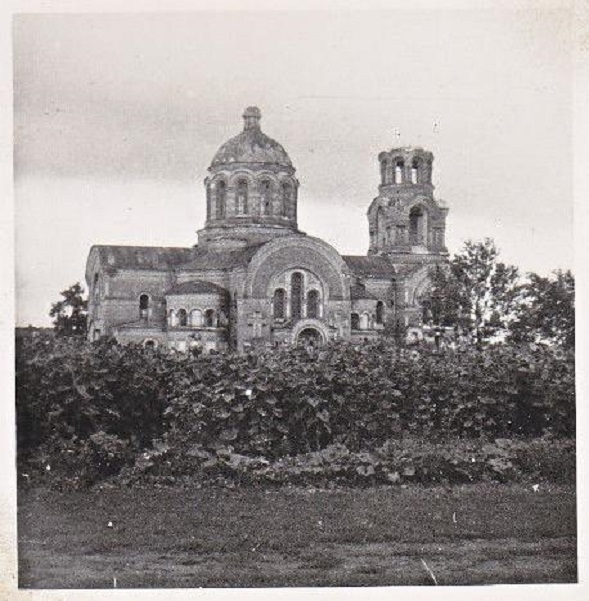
[13,9,573,325]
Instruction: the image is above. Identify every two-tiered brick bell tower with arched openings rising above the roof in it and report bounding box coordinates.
[368,147,448,262]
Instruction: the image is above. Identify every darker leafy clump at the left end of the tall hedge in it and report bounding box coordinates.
[16,337,165,483]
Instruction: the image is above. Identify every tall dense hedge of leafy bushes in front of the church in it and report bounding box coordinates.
[16,337,575,484]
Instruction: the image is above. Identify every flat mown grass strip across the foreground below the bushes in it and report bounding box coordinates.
[18,485,576,588]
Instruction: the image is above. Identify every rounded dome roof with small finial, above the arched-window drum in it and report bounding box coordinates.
[211,106,292,167]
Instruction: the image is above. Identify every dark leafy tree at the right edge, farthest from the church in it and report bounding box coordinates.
[510,270,575,349]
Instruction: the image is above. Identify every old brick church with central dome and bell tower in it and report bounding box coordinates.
[86,107,448,352]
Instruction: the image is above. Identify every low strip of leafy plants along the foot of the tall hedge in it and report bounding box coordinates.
[119,438,575,486]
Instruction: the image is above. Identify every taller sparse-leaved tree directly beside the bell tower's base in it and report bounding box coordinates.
[424,238,521,346]
